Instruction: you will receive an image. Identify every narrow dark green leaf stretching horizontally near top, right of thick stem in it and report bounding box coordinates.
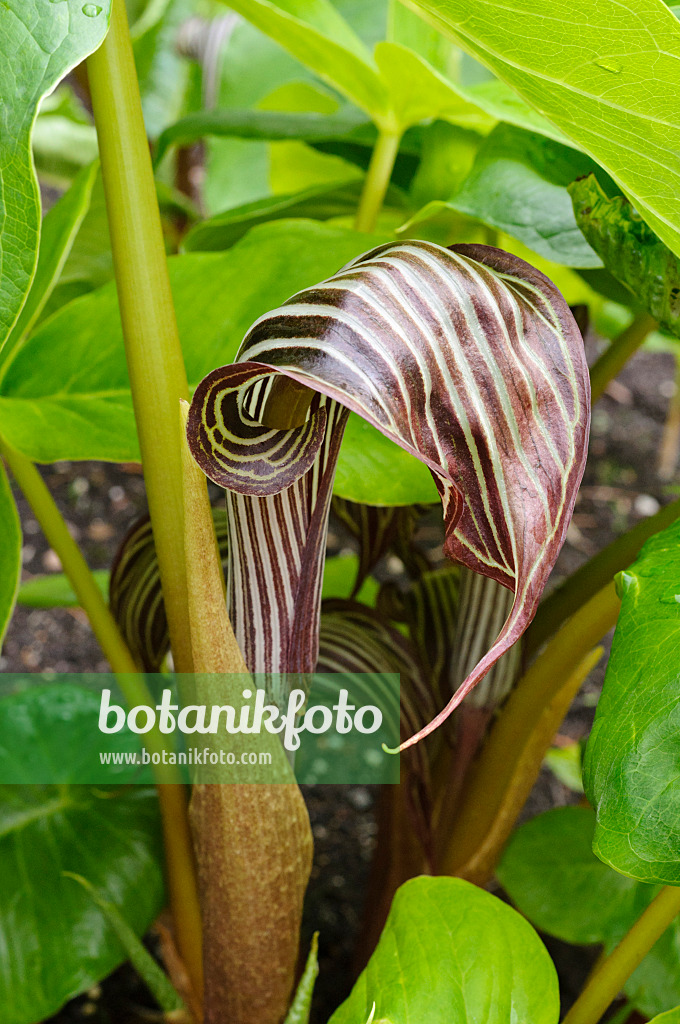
[155,108,369,165]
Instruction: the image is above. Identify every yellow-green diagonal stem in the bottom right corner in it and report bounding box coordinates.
[564,886,680,1024]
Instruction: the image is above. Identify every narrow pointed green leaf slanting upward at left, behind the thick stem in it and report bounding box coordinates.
[3,162,98,368]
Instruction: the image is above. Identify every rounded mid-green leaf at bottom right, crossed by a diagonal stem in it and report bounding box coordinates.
[498,807,680,1017]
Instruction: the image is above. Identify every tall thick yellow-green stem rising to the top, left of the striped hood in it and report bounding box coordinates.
[87,0,195,672]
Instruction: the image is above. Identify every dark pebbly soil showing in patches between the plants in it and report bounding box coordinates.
[0,352,673,1024]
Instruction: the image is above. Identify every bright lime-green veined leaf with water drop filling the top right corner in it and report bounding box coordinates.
[405,0,680,260]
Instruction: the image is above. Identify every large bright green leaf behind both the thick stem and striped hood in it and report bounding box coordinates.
[0,221,436,505]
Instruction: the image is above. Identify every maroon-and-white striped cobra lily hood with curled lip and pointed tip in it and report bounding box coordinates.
[187,242,589,745]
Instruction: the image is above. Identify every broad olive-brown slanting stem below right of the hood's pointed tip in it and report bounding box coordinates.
[442,583,620,884]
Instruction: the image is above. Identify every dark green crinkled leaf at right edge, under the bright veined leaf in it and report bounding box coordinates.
[568,174,680,337]
